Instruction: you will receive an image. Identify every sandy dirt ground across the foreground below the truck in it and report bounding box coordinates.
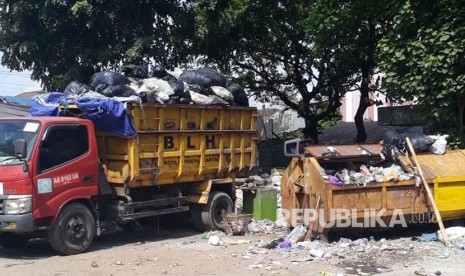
[0,224,465,276]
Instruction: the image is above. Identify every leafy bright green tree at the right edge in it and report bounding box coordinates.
[380,0,465,136]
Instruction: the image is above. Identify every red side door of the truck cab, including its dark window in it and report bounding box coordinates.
[33,124,98,218]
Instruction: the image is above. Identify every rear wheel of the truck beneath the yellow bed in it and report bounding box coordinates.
[201,191,234,230]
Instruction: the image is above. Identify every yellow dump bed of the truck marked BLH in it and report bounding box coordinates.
[97,104,257,188]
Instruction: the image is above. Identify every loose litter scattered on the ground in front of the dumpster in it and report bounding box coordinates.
[241,227,465,275]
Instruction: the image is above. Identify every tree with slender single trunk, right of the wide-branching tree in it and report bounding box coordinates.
[306,0,393,143]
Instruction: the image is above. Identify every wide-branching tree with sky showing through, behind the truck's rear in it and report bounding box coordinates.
[188,0,352,143]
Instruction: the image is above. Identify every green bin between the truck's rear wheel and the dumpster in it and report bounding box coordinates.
[243,188,278,221]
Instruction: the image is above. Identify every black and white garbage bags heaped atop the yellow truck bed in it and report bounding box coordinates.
[63,64,249,106]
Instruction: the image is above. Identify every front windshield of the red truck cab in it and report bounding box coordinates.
[0,120,40,166]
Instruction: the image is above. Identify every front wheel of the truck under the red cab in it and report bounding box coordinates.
[48,203,96,255]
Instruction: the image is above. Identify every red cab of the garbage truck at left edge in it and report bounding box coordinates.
[0,117,98,252]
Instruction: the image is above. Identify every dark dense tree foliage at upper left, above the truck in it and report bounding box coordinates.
[0,0,192,90]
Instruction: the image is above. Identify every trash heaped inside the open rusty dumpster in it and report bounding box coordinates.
[327,164,414,187]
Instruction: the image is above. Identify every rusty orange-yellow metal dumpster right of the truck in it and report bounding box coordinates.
[281,144,465,242]
